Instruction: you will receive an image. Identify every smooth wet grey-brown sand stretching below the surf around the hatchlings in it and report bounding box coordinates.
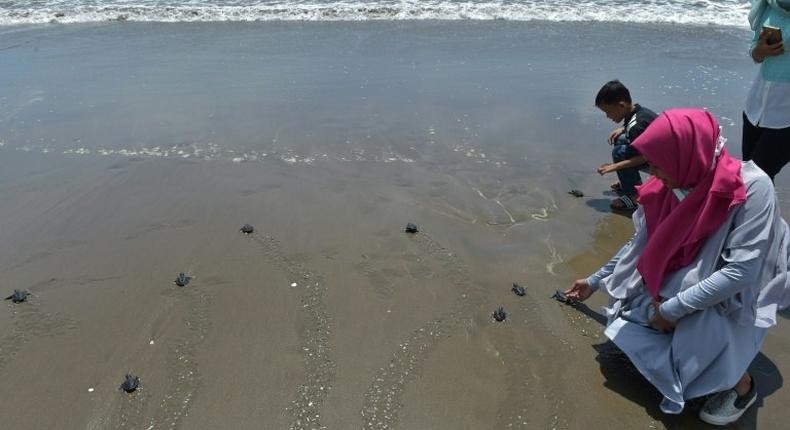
[0,23,790,429]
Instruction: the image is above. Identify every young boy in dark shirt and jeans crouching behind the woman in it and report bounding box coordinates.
[595,80,656,210]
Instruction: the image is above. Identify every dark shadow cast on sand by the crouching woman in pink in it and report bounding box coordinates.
[574,303,784,430]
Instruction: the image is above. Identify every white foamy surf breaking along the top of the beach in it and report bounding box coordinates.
[0,0,749,27]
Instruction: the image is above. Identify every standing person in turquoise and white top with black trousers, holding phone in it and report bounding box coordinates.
[741,0,790,180]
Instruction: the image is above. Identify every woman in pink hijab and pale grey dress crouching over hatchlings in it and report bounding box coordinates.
[566,109,790,425]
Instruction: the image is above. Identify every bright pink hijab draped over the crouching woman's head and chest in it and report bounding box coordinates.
[632,109,746,300]
